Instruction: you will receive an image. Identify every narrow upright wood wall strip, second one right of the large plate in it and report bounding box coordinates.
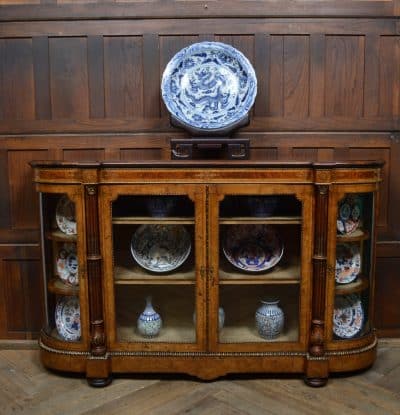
[310,33,325,118]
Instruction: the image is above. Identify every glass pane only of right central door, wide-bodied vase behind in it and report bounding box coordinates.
[219,195,302,343]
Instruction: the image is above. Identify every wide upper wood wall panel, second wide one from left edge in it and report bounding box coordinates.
[49,37,89,119]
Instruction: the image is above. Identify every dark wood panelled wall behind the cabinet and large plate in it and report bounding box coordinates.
[0,0,400,339]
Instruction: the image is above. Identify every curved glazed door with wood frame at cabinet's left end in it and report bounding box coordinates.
[39,185,89,350]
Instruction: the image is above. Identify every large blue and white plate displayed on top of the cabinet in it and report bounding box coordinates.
[161,42,257,132]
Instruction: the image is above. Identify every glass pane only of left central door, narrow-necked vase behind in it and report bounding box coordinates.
[112,195,196,343]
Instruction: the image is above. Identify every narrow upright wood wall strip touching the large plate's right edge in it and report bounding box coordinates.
[254,33,270,117]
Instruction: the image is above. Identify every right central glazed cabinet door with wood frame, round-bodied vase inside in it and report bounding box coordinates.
[209,184,313,352]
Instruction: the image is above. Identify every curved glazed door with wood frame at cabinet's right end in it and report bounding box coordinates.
[326,186,377,348]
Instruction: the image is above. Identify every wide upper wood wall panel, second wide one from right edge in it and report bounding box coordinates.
[325,36,364,117]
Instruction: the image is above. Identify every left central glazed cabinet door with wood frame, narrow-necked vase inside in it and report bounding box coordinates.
[100,184,205,352]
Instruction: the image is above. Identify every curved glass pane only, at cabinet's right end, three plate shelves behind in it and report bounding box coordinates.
[333,193,374,340]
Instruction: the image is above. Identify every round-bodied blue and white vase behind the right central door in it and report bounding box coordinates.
[255,300,285,340]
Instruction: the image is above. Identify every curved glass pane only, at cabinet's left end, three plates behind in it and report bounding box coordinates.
[41,193,82,343]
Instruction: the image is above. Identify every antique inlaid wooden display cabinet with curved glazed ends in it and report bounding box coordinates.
[31,161,382,386]
